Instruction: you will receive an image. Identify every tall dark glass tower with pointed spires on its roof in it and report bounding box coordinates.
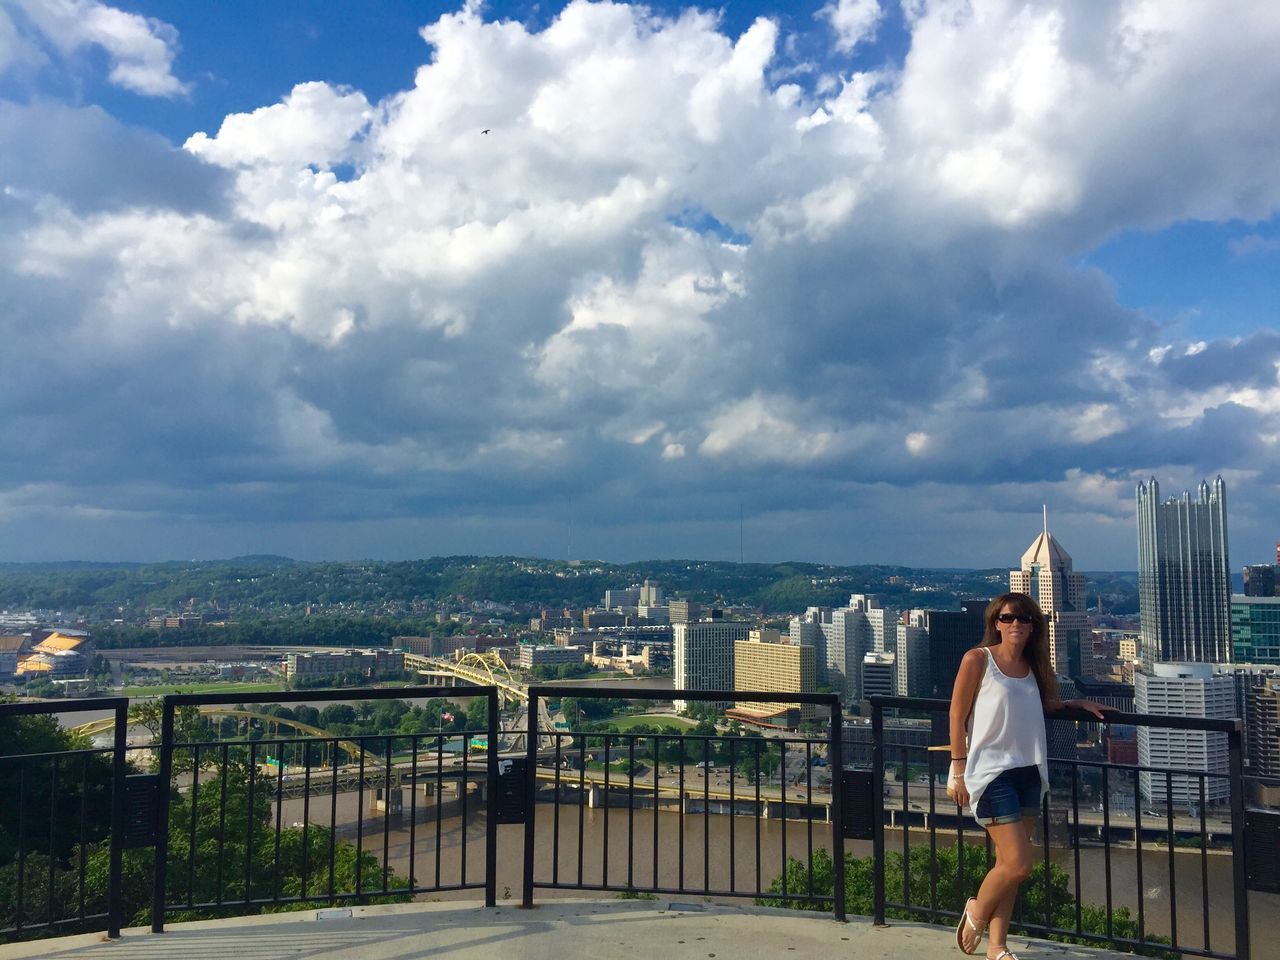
[1138,476,1231,664]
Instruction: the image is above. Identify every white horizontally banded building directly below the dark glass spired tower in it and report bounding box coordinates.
[1134,663,1236,809]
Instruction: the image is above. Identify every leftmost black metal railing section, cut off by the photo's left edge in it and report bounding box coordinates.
[0,698,129,940]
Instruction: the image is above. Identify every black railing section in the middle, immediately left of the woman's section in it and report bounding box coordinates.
[524,686,845,919]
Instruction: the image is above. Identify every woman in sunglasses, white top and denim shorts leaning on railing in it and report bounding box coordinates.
[951,594,1105,960]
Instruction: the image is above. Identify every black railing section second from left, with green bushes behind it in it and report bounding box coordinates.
[151,686,500,933]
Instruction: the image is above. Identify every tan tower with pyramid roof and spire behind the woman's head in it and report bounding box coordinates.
[1009,512,1093,677]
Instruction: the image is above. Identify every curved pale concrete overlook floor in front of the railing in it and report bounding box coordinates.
[0,900,1132,960]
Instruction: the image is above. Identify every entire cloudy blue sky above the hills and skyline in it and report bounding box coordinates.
[0,0,1280,570]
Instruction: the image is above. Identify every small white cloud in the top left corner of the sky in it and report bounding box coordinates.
[9,0,189,97]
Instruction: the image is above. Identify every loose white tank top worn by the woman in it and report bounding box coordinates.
[965,646,1048,810]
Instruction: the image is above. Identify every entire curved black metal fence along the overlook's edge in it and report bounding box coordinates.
[0,685,1274,960]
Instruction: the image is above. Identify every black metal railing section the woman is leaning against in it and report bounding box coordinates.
[872,696,1249,960]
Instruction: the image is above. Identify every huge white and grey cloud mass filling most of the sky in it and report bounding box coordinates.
[0,0,1280,566]
